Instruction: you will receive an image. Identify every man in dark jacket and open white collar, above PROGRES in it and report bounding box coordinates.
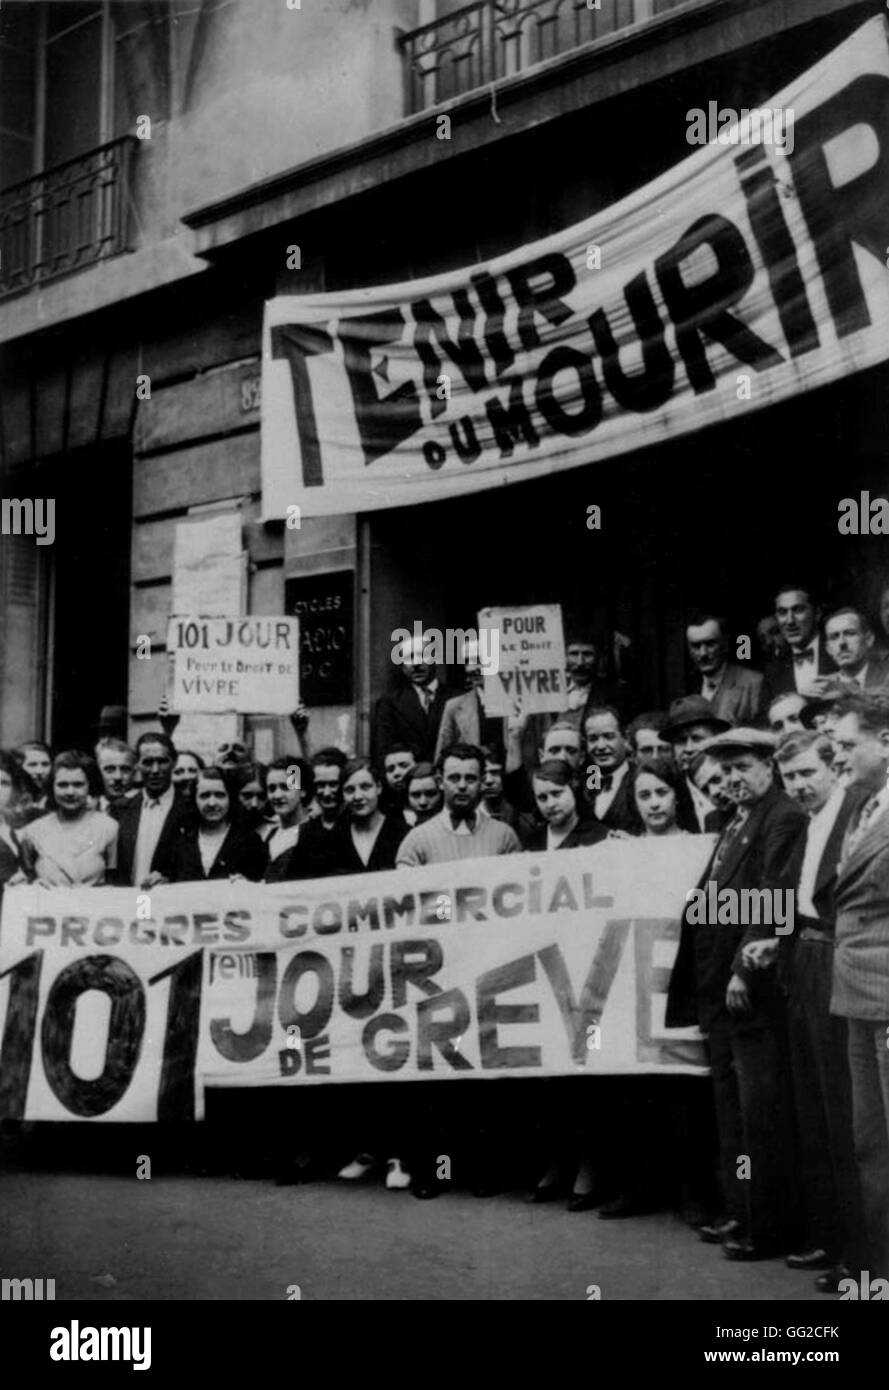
[111,734,192,888]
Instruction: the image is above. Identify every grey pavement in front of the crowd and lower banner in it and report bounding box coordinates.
[0,1166,836,1311]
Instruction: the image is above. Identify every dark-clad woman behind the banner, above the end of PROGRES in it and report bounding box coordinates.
[158,767,267,883]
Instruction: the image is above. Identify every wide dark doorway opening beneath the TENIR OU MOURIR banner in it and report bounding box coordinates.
[371,364,889,709]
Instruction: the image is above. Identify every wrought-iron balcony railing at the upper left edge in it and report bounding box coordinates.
[0,135,138,297]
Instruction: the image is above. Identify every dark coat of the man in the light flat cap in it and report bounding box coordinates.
[665,785,806,1033]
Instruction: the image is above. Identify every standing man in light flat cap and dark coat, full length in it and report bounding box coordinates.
[667,728,804,1259]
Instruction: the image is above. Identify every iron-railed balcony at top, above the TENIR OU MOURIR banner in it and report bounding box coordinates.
[399,0,685,115]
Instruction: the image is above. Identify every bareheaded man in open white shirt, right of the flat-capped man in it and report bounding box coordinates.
[743,730,867,1293]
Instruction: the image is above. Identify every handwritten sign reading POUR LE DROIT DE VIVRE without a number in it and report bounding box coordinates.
[478,603,567,714]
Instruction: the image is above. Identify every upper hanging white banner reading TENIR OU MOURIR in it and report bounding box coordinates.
[263,18,889,520]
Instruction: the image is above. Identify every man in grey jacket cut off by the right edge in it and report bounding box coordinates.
[831,691,889,1279]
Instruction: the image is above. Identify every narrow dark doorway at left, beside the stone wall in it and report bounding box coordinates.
[44,443,132,751]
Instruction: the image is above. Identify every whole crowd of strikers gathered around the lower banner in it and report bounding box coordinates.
[0,582,889,1291]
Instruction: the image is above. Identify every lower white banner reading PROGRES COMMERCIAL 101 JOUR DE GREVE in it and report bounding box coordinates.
[0,835,713,1120]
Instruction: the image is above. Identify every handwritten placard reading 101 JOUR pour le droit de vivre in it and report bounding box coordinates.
[167,614,300,714]
